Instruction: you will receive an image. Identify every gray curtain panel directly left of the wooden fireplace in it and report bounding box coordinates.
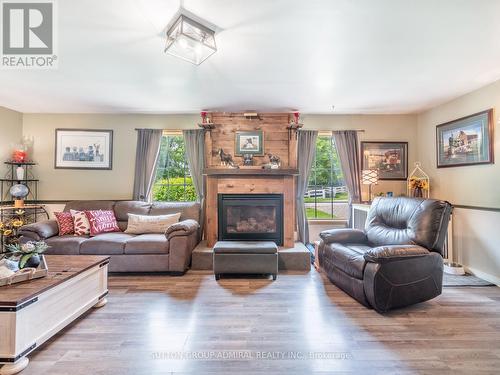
[182,129,205,233]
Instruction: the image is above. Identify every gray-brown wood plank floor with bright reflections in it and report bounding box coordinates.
[23,270,500,375]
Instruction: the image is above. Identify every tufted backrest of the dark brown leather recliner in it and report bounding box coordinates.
[365,197,452,254]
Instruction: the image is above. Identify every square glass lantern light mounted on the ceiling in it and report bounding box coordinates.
[165,14,217,65]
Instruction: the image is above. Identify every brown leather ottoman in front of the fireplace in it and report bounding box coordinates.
[214,241,278,280]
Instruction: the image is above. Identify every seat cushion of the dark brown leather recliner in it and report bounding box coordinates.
[324,243,371,280]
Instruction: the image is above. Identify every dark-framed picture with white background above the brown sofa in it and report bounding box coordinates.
[54,129,113,169]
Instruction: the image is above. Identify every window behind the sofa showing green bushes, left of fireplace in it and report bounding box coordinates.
[153,133,196,202]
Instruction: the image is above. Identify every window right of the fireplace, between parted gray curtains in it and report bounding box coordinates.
[305,133,349,220]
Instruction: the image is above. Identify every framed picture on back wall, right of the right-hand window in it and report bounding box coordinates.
[361,142,408,180]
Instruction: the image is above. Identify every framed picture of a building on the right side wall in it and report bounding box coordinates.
[436,109,493,168]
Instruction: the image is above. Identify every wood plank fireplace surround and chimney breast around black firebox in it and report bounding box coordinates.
[205,113,297,248]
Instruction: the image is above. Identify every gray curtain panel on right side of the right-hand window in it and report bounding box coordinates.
[333,130,361,226]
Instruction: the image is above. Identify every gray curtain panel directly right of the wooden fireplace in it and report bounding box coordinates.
[297,130,318,244]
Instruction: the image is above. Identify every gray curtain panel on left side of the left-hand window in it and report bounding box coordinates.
[133,129,163,201]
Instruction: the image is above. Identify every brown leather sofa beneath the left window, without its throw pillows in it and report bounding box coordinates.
[20,201,200,274]
